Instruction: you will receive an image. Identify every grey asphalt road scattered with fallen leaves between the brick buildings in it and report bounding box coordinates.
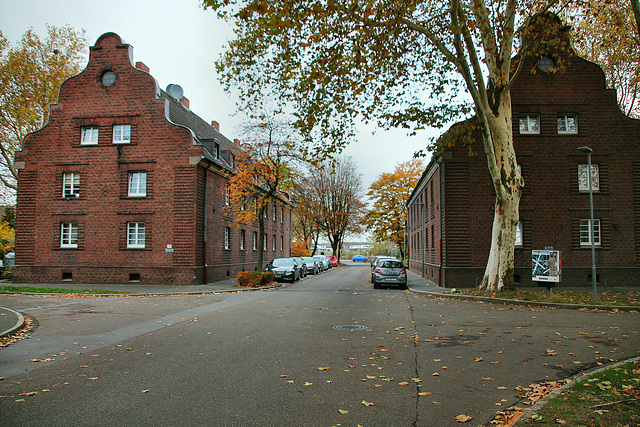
[0,264,640,427]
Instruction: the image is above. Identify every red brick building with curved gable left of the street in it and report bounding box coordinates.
[13,33,291,284]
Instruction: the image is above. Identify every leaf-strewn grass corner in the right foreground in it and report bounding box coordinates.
[518,361,640,426]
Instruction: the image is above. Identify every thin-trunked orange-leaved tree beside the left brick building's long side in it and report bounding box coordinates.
[224,116,299,271]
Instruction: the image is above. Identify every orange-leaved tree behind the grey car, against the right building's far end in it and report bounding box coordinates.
[364,158,424,259]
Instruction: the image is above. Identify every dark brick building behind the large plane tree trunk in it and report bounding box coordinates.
[407,17,640,287]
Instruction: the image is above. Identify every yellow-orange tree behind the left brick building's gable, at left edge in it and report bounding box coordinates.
[0,26,87,199]
